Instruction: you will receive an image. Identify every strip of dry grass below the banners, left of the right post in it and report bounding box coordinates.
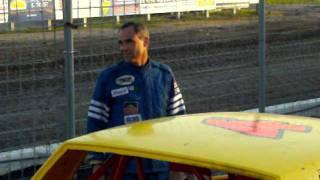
[0,9,257,34]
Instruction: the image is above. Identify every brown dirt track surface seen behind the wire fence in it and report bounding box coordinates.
[0,6,320,151]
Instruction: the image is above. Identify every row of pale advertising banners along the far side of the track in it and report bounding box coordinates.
[0,0,258,23]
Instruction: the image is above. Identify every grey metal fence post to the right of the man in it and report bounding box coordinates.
[258,0,266,112]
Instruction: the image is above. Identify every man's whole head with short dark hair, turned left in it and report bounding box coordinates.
[119,22,149,66]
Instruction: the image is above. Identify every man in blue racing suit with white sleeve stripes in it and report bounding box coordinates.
[87,22,186,179]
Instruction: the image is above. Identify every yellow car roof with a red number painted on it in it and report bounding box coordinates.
[35,112,320,180]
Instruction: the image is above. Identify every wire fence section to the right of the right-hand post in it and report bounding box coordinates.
[266,4,320,117]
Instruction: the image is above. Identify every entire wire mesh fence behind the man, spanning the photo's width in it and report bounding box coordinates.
[0,0,320,179]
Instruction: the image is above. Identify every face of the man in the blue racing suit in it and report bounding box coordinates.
[119,27,148,63]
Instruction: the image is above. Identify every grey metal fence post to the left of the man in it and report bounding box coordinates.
[63,0,75,138]
